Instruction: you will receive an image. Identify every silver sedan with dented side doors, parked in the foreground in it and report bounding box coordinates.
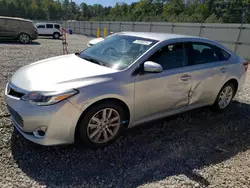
[5,32,248,148]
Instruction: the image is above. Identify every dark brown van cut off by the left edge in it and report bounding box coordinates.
[0,16,38,44]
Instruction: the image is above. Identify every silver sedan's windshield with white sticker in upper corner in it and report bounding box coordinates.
[79,35,158,70]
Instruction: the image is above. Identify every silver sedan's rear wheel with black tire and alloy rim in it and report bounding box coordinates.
[213,83,236,111]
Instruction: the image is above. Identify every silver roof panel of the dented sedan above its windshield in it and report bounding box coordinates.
[117,32,205,41]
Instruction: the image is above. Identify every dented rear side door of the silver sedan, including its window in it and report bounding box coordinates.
[184,42,230,106]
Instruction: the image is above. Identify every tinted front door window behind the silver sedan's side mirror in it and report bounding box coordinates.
[149,43,185,70]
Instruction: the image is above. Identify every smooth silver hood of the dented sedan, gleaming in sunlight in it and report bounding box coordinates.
[11,54,117,91]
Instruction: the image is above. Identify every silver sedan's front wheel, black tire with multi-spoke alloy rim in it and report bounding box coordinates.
[77,102,125,148]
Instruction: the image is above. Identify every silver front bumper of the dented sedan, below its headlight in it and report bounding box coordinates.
[5,84,81,146]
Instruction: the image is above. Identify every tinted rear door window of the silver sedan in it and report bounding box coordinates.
[186,43,223,65]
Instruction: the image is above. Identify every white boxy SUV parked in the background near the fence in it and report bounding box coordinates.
[36,23,62,39]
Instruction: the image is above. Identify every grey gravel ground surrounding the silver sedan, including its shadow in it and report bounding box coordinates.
[0,35,250,188]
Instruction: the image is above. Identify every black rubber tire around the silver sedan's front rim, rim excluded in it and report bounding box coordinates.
[78,103,125,148]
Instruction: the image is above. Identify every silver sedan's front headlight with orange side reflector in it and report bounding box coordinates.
[21,90,78,106]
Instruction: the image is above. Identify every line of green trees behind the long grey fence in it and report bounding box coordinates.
[0,0,250,23]
